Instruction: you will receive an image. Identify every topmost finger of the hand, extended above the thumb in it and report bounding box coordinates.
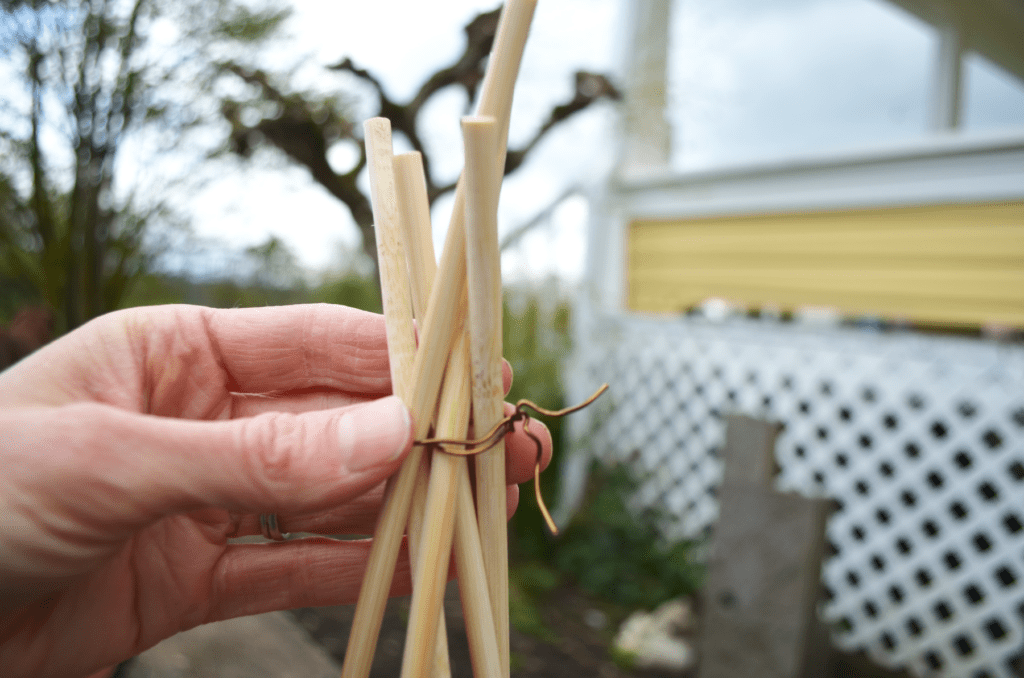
[0,304,391,411]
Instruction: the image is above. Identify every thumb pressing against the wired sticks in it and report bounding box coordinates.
[56,396,413,521]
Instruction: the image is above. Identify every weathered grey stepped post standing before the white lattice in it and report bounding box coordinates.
[700,416,834,678]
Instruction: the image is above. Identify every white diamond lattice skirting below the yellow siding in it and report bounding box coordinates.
[569,320,1024,678]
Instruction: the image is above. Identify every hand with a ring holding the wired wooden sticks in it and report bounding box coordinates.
[0,305,551,676]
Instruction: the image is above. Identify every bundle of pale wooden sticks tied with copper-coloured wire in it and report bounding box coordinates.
[342,0,537,678]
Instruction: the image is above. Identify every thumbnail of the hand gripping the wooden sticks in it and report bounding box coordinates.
[338,395,412,471]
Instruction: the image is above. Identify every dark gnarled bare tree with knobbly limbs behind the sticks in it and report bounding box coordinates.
[221,7,620,270]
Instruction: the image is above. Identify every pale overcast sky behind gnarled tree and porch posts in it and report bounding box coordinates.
[180,0,1024,279]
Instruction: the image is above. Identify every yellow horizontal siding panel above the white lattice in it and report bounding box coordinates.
[627,201,1024,327]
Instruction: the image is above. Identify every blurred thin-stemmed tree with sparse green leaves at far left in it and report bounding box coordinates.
[0,0,287,330]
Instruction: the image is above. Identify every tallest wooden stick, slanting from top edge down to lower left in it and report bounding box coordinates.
[342,0,537,678]
